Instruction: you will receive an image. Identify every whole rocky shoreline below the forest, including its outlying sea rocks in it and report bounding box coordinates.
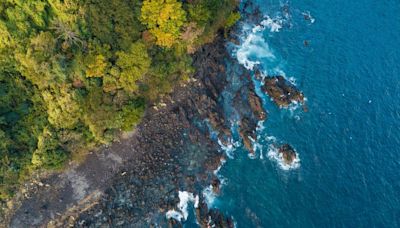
[4,16,304,227]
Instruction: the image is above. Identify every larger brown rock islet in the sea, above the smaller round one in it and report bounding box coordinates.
[263,76,304,107]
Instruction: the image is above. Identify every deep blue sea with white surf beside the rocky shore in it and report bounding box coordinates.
[203,0,400,227]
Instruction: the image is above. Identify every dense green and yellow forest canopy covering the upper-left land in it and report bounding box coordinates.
[0,0,239,200]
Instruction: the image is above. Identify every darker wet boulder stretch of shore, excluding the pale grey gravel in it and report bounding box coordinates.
[75,33,234,227]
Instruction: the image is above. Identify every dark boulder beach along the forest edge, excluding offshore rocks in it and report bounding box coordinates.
[5,31,234,227]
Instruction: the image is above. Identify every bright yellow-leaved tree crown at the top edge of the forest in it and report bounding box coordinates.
[140,0,186,47]
